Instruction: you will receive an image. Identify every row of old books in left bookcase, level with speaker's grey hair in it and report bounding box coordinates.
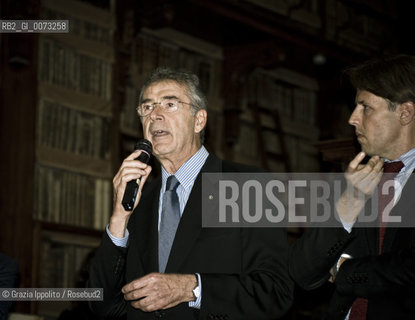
[38,37,112,100]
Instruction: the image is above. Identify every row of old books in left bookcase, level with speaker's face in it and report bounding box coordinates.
[36,99,111,159]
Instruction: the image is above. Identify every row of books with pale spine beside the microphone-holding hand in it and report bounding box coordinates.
[34,165,112,230]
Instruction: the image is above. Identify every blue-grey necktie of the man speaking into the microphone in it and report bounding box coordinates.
[159,175,180,272]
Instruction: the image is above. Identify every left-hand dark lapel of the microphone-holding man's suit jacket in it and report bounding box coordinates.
[134,179,161,273]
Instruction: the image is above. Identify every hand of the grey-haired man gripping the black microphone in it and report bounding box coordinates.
[109,150,151,238]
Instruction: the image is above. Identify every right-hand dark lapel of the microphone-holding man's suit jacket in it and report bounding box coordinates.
[166,155,222,272]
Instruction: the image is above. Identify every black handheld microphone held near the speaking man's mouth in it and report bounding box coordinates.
[121,139,153,211]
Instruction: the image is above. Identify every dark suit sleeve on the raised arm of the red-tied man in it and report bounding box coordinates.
[289,227,354,290]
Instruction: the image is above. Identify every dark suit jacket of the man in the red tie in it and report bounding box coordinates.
[290,175,415,320]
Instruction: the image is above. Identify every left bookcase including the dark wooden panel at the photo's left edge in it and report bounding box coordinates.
[0,0,119,319]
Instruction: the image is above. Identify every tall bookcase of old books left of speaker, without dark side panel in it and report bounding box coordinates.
[32,0,118,318]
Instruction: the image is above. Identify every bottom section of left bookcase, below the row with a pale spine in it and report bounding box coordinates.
[32,222,102,319]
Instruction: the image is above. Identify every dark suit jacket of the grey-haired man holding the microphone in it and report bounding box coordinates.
[89,155,293,320]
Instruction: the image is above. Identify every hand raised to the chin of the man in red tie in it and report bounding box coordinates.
[336,152,383,223]
